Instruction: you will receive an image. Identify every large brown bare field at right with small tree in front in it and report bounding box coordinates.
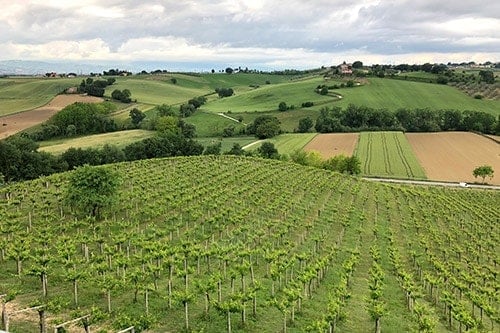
[406,132,500,185]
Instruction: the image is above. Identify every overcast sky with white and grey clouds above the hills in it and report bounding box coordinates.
[0,0,500,69]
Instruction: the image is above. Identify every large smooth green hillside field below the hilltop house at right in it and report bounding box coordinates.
[335,78,500,115]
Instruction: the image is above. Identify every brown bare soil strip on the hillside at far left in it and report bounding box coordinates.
[0,95,103,139]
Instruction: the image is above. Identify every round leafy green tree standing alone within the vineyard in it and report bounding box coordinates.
[66,165,120,219]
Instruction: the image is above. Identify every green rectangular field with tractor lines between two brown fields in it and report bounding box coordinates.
[355,132,426,179]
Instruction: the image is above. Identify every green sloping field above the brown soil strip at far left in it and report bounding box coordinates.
[0,78,81,116]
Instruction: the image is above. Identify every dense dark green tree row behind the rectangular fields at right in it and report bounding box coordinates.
[315,104,500,134]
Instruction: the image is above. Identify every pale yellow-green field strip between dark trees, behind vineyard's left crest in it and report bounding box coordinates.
[39,130,155,155]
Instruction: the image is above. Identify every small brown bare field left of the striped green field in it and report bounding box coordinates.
[304,133,359,159]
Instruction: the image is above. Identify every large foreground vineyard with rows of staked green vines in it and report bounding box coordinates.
[0,156,500,333]
